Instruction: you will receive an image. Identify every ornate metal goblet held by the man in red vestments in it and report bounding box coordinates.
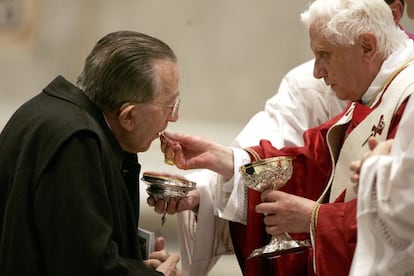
[240,156,311,259]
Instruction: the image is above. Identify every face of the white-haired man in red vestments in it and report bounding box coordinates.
[309,27,372,101]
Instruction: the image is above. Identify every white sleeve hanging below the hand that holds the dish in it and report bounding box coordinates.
[177,170,233,276]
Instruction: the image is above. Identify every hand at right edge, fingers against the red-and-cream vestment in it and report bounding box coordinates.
[350,137,393,183]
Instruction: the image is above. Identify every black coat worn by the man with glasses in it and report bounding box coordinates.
[0,77,162,276]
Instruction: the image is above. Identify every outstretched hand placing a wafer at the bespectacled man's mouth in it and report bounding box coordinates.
[160,132,233,179]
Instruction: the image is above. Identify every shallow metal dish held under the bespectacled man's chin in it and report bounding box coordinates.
[141,173,196,225]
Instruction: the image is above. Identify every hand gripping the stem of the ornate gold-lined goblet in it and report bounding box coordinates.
[256,190,316,235]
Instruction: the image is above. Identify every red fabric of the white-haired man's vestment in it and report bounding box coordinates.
[230,99,407,276]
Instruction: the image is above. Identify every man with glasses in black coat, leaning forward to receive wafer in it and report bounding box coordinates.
[0,31,180,276]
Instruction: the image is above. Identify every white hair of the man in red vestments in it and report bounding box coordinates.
[301,0,407,58]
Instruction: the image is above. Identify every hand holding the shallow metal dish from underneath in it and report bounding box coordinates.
[147,189,200,215]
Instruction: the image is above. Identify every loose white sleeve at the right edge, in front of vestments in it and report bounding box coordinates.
[351,98,414,275]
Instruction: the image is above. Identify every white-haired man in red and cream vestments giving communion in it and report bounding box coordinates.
[157,0,414,275]
